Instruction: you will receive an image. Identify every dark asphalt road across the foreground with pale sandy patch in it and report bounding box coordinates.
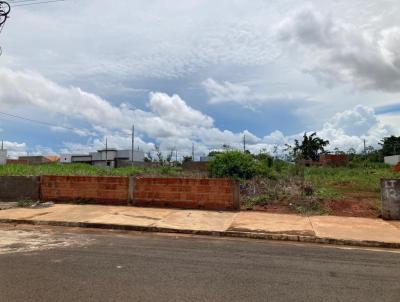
[0,227,400,302]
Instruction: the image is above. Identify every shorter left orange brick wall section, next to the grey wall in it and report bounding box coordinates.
[40,176,129,205]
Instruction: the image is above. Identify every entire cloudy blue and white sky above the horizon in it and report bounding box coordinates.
[0,0,400,157]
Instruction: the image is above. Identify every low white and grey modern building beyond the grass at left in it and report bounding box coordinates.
[60,149,144,168]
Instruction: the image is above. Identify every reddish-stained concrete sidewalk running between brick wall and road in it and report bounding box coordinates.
[0,204,400,248]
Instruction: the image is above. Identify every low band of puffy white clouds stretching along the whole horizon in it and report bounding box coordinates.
[0,69,398,154]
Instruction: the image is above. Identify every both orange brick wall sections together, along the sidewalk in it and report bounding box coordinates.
[40,176,240,210]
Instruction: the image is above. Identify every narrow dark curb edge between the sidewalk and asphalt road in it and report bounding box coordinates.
[0,219,400,249]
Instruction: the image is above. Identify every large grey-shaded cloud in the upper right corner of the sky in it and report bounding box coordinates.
[277,6,400,92]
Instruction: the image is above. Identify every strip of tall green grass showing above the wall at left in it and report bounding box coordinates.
[0,164,182,176]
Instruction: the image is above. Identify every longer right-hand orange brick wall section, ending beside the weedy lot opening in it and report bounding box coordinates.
[133,177,239,210]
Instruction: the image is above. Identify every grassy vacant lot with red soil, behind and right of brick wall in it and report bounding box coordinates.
[0,162,400,217]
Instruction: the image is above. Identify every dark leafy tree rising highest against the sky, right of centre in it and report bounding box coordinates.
[293,132,329,161]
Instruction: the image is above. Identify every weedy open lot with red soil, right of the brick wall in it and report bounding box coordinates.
[242,164,400,217]
